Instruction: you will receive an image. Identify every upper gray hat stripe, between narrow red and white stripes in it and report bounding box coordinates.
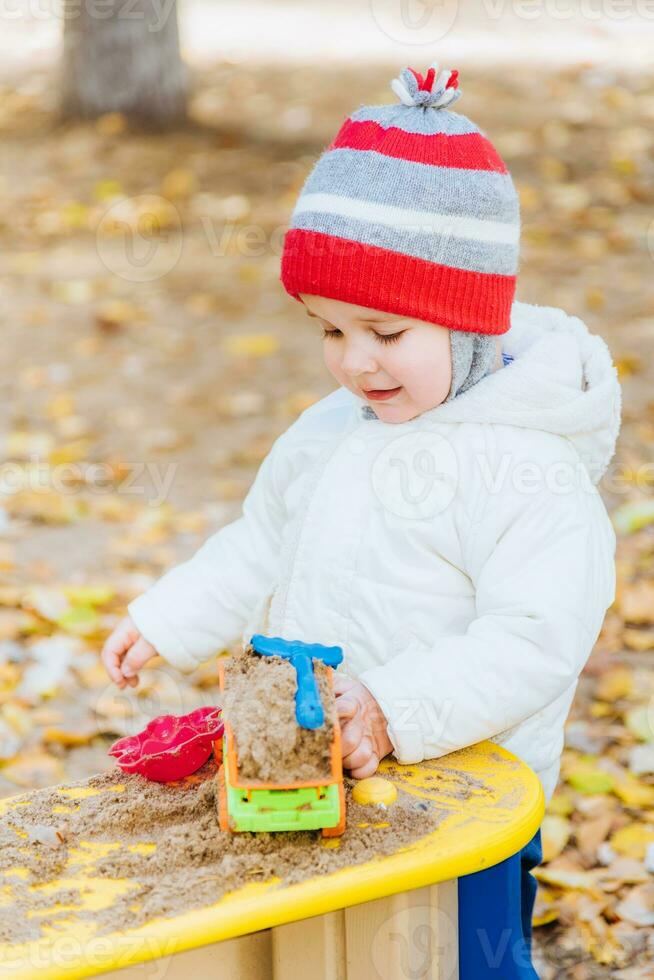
[300,147,520,224]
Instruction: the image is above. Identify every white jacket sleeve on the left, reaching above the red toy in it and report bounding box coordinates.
[127,430,289,671]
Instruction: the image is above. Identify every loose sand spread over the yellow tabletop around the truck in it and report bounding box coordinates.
[0,758,442,943]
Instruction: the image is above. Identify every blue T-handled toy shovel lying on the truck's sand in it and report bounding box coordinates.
[250,633,343,728]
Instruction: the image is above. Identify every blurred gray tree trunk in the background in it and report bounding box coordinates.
[61,0,186,129]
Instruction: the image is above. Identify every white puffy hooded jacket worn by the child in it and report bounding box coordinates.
[129,302,621,799]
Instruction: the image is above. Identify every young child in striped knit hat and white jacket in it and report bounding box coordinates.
[103,65,620,978]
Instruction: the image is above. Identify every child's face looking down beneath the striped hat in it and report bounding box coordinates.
[300,293,452,422]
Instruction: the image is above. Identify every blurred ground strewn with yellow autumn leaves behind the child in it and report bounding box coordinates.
[0,5,654,980]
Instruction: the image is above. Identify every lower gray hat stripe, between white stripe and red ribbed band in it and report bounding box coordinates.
[290,211,519,276]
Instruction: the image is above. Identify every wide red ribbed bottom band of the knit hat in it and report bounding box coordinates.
[280,228,516,334]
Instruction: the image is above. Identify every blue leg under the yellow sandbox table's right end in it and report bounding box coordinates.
[458,830,543,980]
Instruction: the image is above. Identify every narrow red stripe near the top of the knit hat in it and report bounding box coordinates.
[327,119,508,174]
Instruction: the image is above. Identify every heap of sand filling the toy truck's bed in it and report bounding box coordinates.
[223,645,337,785]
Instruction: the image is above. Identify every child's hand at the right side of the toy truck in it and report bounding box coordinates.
[334,673,393,779]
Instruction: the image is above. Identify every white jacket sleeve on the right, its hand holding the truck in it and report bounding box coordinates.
[359,437,615,763]
